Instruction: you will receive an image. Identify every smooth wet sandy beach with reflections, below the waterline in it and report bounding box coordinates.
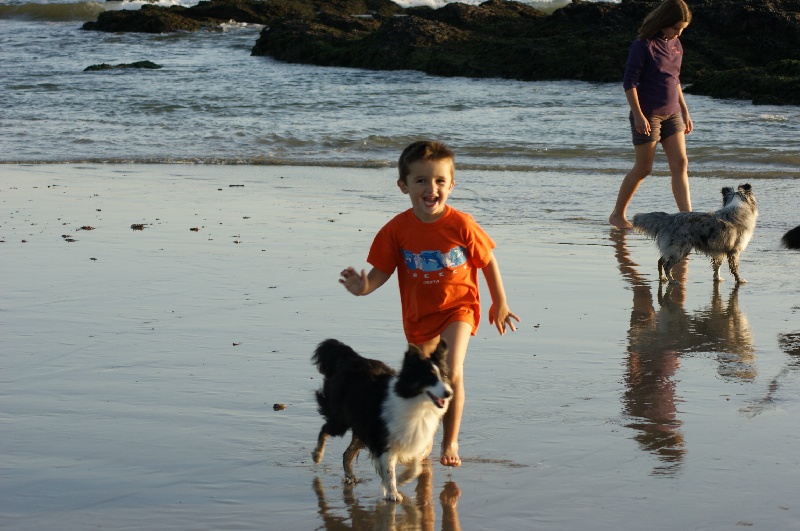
[0,164,800,530]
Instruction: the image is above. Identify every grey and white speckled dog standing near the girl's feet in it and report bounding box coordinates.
[633,184,758,284]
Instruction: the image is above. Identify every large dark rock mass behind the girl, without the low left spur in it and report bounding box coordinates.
[252,0,800,103]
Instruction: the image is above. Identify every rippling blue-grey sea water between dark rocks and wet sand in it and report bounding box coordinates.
[0,0,800,179]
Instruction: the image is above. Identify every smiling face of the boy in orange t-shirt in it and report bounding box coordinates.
[397,159,456,223]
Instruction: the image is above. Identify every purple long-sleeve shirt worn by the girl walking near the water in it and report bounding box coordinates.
[622,37,683,116]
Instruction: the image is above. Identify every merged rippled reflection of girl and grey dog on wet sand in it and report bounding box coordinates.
[611,230,755,474]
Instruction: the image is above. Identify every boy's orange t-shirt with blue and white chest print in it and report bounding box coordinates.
[367,205,495,344]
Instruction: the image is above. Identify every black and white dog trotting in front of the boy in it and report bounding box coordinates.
[311,339,453,502]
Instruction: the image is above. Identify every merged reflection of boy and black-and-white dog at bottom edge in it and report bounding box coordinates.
[314,459,461,531]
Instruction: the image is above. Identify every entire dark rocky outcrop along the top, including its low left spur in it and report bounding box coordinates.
[84,0,800,104]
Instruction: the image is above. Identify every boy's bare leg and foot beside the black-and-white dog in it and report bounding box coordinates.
[439,321,472,466]
